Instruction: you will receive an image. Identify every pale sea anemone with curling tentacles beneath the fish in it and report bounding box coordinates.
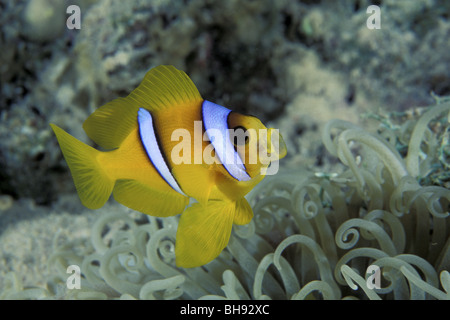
[1,98,450,299]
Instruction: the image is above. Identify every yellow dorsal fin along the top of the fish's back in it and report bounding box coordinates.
[83,66,202,149]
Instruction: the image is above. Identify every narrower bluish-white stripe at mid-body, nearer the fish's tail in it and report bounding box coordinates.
[138,108,186,196]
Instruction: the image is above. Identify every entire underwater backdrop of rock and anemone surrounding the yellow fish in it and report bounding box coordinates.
[0,0,450,300]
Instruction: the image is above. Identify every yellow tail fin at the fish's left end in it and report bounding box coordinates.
[50,124,115,209]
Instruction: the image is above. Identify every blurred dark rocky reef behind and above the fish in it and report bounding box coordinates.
[0,0,450,204]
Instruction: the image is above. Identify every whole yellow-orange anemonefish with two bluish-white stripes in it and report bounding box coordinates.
[51,66,286,268]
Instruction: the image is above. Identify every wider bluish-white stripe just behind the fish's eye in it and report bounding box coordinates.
[202,100,251,181]
